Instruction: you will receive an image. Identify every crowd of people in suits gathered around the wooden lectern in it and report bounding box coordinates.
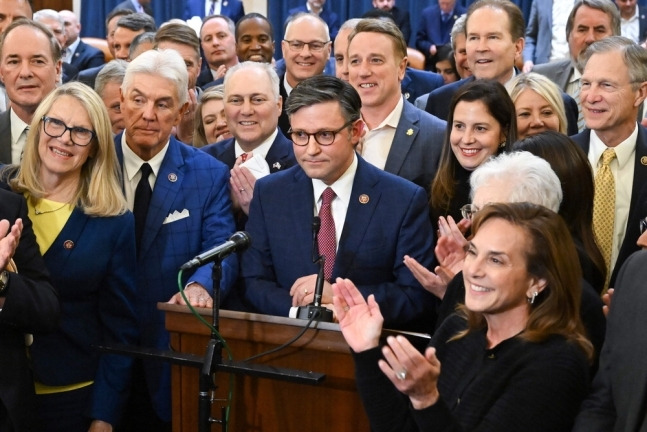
[0,0,647,432]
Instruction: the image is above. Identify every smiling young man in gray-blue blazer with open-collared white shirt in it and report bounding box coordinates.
[348,19,446,191]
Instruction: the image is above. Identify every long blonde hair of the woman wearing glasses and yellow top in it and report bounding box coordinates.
[10,82,127,216]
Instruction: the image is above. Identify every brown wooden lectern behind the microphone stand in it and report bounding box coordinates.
[159,303,369,432]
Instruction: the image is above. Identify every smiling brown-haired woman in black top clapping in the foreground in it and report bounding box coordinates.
[333,203,592,432]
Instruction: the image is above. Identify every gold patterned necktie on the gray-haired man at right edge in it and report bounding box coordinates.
[593,148,616,280]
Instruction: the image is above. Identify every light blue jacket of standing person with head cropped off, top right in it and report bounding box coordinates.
[523,0,553,64]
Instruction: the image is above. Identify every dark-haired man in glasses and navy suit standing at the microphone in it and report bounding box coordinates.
[241,75,435,331]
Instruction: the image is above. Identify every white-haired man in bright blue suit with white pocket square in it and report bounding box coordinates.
[115,50,237,431]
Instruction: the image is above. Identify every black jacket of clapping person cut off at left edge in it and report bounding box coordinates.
[0,189,60,431]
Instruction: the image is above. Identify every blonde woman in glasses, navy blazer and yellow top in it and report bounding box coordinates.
[10,83,137,432]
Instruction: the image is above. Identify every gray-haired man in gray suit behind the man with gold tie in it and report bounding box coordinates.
[532,0,620,99]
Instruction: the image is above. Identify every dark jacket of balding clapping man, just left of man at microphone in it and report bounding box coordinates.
[200,130,297,173]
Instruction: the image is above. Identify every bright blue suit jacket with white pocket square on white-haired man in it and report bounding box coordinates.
[115,134,238,421]
